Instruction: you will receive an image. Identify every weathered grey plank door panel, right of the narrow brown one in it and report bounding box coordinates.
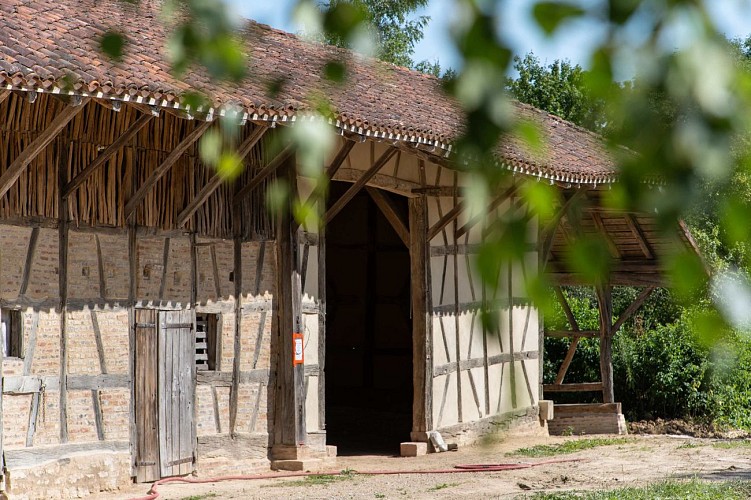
[159,310,196,477]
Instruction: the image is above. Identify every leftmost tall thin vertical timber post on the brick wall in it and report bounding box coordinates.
[57,137,70,443]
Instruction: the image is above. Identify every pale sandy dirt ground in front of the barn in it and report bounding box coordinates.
[98,435,751,500]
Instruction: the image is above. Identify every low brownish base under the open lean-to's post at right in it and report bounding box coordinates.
[548,403,628,436]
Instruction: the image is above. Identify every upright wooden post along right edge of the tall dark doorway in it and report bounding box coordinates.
[408,195,433,440]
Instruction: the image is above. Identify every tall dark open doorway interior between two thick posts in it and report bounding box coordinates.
[326,182,412,455]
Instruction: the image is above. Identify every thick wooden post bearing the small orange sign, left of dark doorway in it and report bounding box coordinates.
[274,155,307,446]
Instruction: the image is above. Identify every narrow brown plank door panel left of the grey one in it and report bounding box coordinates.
[133,309,159,483]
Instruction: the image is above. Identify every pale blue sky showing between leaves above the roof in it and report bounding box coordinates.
[227,0,751,74]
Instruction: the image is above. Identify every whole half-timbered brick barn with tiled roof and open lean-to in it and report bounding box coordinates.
[0,0,691,498]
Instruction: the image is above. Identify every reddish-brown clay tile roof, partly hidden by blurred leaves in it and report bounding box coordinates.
[0,0,617,184]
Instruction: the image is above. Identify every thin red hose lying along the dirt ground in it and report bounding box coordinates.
[131,458,581,500]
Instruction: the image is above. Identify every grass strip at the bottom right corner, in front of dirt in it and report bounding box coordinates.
[527,479,751,500]
